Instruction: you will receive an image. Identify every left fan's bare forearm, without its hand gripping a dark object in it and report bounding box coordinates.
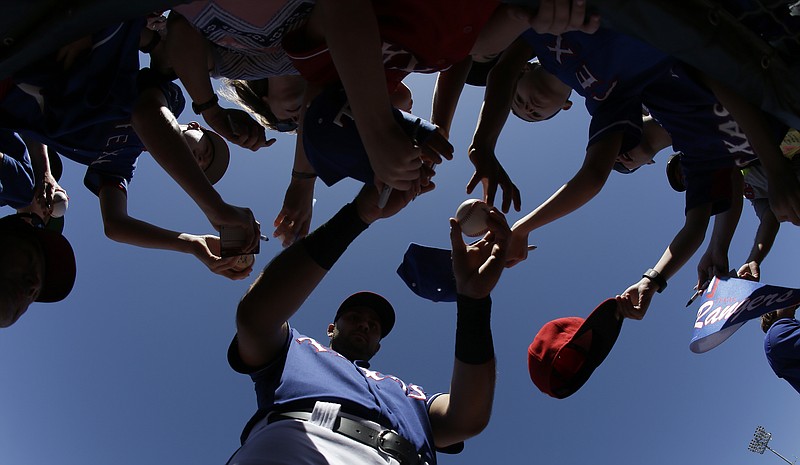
[131,94,225,216]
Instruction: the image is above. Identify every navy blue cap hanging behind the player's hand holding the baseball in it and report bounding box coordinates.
[397,242,456,302]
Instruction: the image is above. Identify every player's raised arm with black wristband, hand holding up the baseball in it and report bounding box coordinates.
[428,208,511,447]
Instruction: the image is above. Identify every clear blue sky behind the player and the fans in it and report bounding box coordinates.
[0,68,800,465]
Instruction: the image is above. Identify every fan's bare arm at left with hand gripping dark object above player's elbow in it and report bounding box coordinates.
[131,88,260,251]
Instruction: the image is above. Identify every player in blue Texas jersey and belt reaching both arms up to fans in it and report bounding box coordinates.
[228,187,510,465]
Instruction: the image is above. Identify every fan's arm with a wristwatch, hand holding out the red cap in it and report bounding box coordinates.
[616,204,711,320]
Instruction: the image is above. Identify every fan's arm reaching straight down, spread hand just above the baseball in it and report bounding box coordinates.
[467,39,533,212]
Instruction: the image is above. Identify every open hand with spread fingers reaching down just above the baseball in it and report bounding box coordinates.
[467,146,522,213]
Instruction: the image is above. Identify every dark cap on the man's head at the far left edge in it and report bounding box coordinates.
[0,214,76,302]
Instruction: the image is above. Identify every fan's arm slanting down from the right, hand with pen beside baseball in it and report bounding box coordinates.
[506,133,622,267]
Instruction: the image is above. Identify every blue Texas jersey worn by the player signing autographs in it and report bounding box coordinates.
[228,328,436,464]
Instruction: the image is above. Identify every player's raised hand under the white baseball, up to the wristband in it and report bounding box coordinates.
[450,208,511,299]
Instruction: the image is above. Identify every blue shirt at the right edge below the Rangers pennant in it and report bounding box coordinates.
[764,318,800,392]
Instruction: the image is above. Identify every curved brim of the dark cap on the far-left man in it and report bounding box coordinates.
[31,228,76,302]
